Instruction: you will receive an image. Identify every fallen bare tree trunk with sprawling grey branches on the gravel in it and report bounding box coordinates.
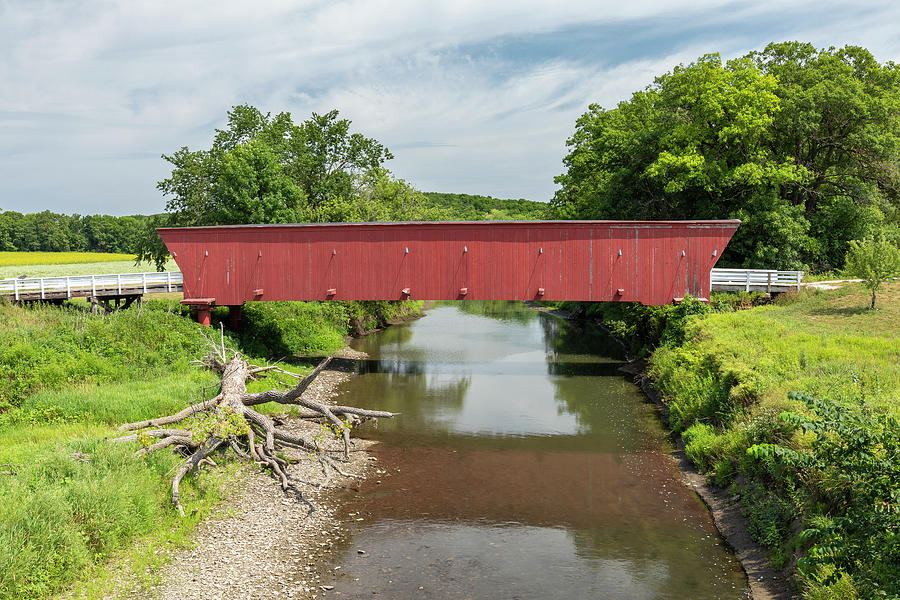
[112,345,394,515]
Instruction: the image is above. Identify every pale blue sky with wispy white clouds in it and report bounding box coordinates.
[0,0,900,215]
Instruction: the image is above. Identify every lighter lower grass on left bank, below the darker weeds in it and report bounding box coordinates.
[0,371,239,599]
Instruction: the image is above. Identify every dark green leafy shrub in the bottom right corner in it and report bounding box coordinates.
[747,393,900,597]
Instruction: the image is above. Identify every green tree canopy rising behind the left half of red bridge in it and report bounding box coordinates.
[138,105,442,266]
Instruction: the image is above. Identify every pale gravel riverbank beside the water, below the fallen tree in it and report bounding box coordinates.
[145,348,378,600]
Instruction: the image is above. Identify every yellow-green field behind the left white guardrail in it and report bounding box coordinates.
[0,252,178,279]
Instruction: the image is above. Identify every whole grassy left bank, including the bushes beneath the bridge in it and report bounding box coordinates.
[0,292,418,599]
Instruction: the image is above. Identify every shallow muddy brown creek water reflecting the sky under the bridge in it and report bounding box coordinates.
[327,303,747,599]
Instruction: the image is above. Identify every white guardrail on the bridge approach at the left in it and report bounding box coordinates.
[0,271,184,300]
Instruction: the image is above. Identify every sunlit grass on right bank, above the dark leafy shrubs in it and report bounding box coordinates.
[652,283,900,423]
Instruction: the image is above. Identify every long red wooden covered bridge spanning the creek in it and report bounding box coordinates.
[159,220,740,324]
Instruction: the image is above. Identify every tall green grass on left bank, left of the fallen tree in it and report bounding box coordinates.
[0,303,227,599]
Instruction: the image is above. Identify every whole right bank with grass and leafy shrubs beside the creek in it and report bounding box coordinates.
[565,282,900,600]
